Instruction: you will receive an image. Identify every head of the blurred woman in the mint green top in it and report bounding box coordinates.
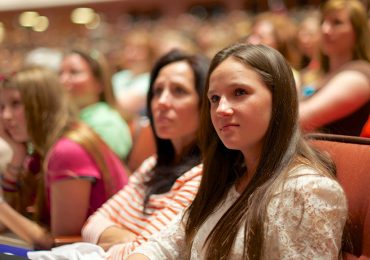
[60,50,115,108]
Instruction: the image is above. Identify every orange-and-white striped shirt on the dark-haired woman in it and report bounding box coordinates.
[82,156,202,259]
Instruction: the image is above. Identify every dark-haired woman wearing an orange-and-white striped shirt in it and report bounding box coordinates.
[82,50,208,259]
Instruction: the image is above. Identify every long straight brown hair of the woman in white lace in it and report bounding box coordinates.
[183,44,335,259]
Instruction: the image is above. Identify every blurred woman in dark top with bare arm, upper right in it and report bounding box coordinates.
[299,0,370,136]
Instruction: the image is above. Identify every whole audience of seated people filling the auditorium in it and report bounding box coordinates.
[0,0,370,259]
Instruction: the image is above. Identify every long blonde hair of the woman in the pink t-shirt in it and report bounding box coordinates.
[4,66,76,157]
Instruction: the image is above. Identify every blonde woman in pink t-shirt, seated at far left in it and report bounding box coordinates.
[0,67,128,248]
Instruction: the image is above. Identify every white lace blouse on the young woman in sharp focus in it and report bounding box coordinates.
[134,166,347,260]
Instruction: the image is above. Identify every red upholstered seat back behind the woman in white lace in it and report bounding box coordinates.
[309,134,370,260]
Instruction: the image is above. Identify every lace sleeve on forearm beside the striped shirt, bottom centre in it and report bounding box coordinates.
[133,213,185,260]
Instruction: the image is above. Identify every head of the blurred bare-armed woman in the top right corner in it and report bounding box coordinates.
[321,0,370,71]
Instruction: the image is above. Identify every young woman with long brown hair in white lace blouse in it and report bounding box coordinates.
[128,44,347,259]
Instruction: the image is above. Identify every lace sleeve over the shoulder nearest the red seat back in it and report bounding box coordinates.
[264,174,347,259]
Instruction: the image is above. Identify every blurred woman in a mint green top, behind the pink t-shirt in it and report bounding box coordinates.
[60,50,132,160]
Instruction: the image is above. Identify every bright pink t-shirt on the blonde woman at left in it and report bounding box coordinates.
[46,138,128,218]
